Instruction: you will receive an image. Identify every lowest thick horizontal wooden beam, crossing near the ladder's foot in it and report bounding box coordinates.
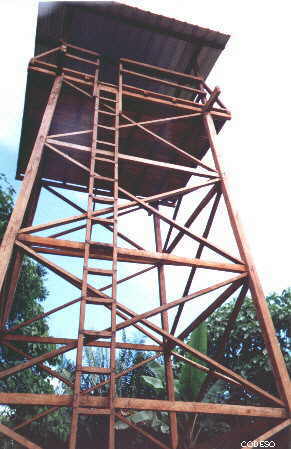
[0,393,287,419]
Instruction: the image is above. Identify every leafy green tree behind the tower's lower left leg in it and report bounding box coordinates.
[0,174,62,449]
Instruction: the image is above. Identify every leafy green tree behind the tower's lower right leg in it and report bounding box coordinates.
[207,288,291,405]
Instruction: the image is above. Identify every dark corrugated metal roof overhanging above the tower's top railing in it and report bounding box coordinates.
[35,2,229,78]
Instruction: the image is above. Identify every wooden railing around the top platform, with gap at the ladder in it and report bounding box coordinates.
[29,42,230,116]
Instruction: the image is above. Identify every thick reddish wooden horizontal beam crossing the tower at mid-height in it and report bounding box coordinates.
[18,234,245,273]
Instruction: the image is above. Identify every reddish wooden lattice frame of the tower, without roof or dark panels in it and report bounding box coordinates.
[0,44,291,449]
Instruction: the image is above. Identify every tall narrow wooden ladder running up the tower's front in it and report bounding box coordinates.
[69,81,121,449]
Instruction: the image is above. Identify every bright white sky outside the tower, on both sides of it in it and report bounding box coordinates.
[0,0,291,293]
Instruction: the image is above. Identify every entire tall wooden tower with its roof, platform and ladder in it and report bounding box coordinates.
[0,2,291,449]
